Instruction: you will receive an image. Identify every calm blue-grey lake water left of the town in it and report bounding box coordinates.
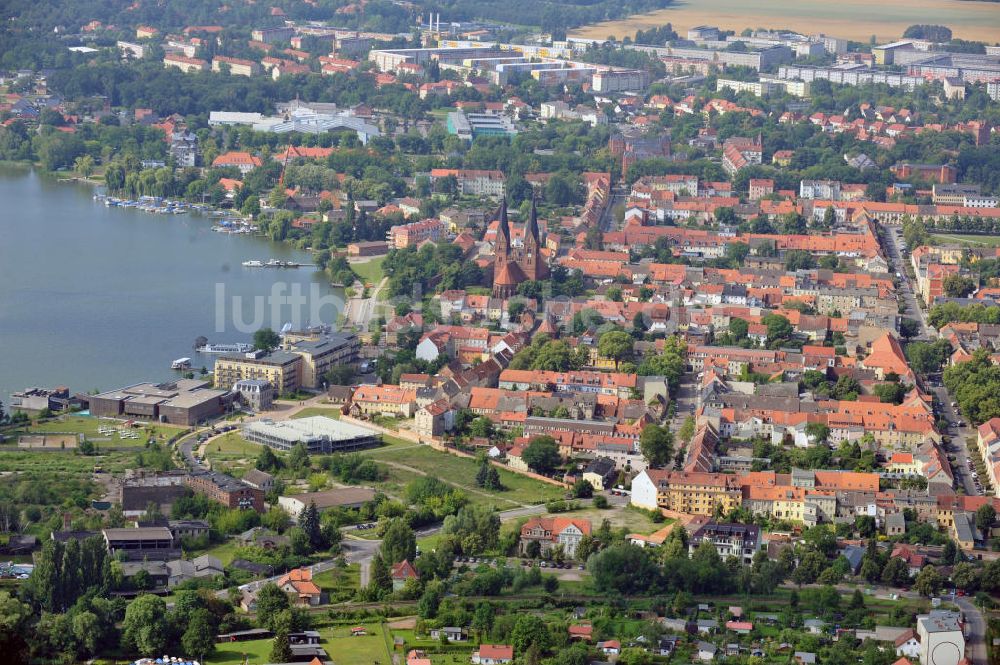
[0,167,343,403]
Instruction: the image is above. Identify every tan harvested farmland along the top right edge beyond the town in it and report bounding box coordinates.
[570,0,1000,44]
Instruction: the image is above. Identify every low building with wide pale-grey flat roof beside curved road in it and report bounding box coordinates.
[243,416,381,453]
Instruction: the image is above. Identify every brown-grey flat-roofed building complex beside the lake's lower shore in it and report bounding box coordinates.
[90,379,229,426]
